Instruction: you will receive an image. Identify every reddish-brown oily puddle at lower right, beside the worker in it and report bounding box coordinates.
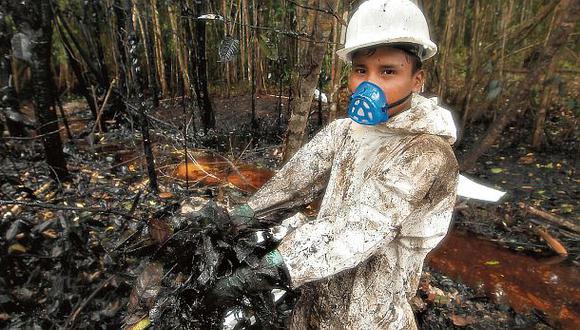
[427,231,580,329]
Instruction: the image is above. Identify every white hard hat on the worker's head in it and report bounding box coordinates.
[336,0,437,62]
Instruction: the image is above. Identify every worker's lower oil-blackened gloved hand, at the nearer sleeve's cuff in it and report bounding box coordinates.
[208,250,290,306]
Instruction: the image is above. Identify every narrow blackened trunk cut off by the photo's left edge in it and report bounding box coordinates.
[0,18,26,136]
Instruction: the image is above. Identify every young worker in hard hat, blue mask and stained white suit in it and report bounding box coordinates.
[214,0,458,329]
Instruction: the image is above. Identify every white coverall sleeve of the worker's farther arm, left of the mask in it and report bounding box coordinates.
[248,120,346,217]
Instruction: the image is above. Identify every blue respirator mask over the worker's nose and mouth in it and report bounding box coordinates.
[348,81,411,125]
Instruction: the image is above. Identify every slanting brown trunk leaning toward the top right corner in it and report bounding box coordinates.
[461,0,580,170]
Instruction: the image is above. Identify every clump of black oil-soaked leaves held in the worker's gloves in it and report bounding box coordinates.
[124,202,295,329]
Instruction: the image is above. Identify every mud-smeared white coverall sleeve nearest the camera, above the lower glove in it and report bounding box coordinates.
[278,137,457,287]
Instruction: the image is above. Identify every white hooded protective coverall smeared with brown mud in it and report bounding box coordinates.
[249,95,458,329]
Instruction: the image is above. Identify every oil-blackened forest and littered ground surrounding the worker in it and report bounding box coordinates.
[0,0,580,328]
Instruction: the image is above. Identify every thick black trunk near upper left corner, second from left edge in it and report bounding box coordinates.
[3,0,68,181]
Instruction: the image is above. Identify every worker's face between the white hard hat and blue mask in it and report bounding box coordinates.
[348,46,425,116]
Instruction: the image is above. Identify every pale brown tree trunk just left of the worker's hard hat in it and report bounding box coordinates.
[283,0,338,161]
